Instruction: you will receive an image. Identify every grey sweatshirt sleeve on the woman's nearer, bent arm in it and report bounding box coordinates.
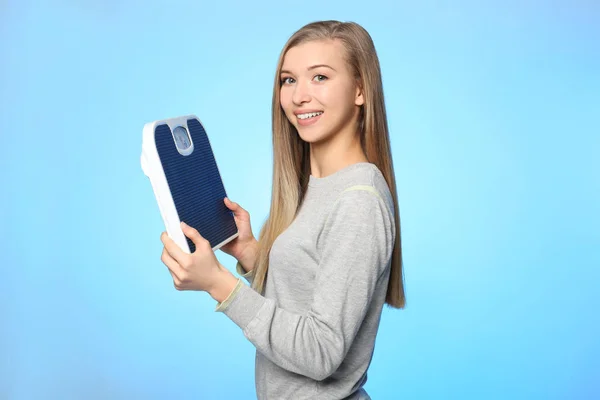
[214,187,395,380]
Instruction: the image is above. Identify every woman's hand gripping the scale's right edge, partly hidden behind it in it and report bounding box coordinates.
[221,197,258,267]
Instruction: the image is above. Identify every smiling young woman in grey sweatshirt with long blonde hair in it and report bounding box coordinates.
[161,21,404,399]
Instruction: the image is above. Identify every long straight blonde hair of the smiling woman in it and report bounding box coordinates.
[252,21,405,308]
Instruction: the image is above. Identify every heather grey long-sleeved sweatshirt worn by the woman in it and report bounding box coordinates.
[215,162,396,400]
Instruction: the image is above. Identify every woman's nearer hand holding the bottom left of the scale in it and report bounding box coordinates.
[160,221,225,292]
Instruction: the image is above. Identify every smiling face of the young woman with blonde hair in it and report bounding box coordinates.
[280,41,364,143]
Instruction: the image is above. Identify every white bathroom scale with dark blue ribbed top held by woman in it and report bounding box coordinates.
[141,115,239,253]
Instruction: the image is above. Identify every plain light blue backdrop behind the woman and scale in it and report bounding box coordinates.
[0,0,600,400]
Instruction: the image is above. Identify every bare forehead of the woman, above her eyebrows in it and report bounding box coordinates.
[282,40,346,72]
